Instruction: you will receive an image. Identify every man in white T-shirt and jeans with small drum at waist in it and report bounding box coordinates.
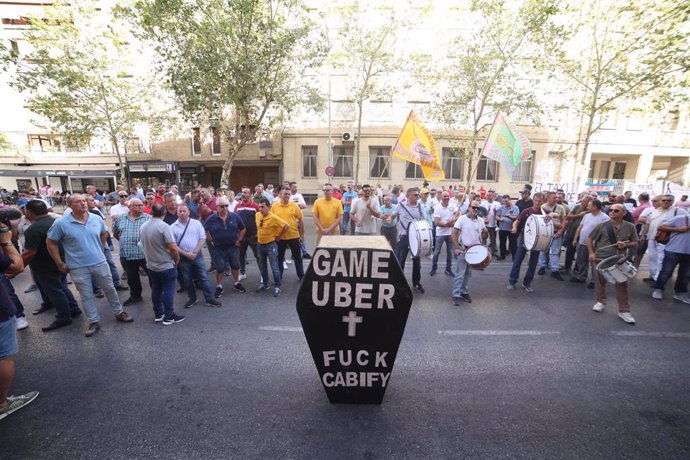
[451,201,491,305]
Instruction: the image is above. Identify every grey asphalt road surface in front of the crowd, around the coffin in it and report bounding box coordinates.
[0,221,690,459]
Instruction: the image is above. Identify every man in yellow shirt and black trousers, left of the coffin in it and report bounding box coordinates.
[271,187,304,280]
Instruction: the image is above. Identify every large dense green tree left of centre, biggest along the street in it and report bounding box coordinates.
[125,0,325,185]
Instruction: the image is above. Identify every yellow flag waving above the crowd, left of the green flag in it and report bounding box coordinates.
[393,110,446,180]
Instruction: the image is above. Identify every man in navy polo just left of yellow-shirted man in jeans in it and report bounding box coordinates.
[204,198,246,298]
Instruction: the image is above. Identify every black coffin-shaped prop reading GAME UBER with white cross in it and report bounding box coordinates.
[297,236,412,404]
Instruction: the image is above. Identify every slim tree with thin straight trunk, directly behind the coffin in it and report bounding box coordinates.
[331,1,398,183]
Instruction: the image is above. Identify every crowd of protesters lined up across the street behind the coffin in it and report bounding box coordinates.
[0,182,690,418]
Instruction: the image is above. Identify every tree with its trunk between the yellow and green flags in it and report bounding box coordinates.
[427,0,562,187]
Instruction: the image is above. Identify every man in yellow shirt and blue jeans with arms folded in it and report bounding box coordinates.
[256,198,290,297]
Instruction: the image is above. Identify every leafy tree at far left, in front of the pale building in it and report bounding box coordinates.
[0,1,167,183]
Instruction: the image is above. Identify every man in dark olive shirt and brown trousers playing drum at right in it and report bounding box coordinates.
[587,203,637,324]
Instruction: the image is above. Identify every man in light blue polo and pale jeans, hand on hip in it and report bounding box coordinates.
[46,194,133,337]
